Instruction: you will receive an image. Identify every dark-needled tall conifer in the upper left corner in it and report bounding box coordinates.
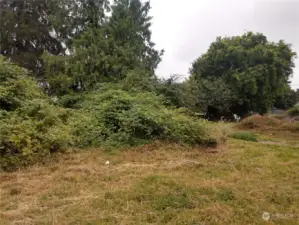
[0,0,68,72]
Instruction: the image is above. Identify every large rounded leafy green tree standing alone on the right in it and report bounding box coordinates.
[190,32,296,113]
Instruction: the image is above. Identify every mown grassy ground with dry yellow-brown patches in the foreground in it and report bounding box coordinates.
[0,130,299,225]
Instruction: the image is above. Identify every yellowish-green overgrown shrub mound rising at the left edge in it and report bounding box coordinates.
[0,59,72,170]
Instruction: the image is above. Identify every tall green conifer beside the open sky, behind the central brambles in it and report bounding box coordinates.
[66,0,163,89]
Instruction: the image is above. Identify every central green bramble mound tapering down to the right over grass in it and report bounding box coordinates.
[74,89,225,147]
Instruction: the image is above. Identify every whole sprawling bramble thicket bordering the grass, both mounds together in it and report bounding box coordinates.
[0,58,226,169]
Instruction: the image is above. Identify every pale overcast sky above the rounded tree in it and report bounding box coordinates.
[151,0,299,88]
